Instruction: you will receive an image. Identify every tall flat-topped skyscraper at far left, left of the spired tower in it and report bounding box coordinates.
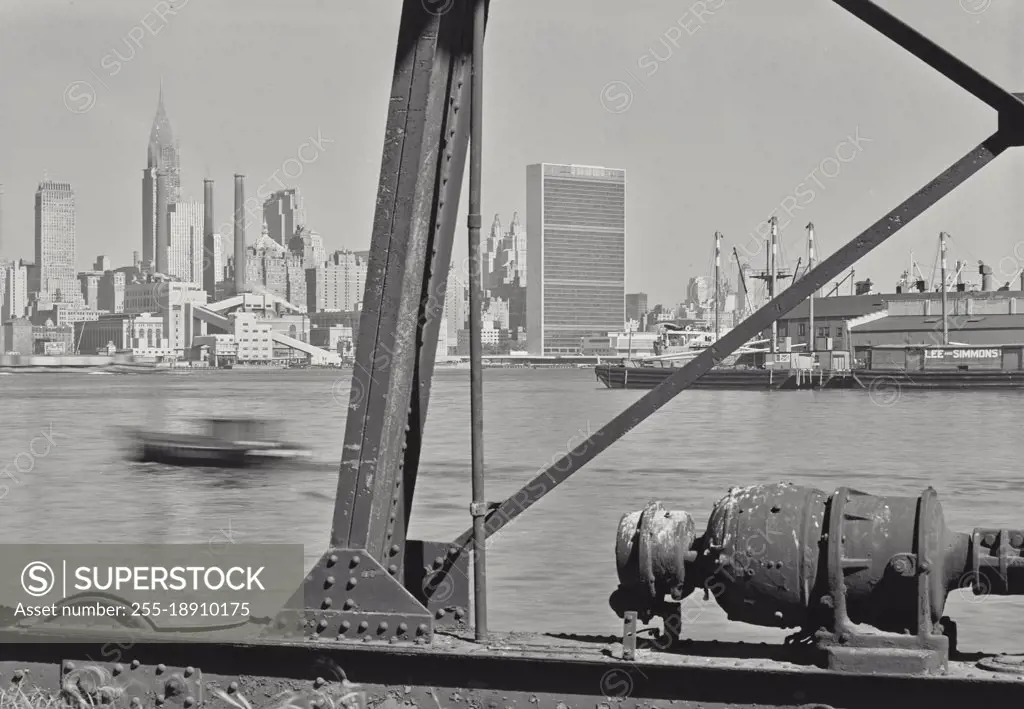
[29,180,83,304]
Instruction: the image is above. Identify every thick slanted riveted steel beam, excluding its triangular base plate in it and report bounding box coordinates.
[331,0,472,560]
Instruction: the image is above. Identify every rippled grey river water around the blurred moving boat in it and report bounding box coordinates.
[0,370,1024,652]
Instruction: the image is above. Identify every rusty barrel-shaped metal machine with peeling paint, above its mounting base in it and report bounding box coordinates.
[611,483,1024,633]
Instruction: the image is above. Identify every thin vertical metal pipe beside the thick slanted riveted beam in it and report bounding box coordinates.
[467,0,487,642]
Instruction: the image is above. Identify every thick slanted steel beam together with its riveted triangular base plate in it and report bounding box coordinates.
[292,0,472,642]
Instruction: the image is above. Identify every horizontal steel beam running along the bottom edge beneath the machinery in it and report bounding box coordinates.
[0,635,1024,709]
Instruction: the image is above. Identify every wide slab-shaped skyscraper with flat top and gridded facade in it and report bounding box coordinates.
[526,163,626,355]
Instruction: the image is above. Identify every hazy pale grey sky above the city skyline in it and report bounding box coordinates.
[0,0,1024,303]
